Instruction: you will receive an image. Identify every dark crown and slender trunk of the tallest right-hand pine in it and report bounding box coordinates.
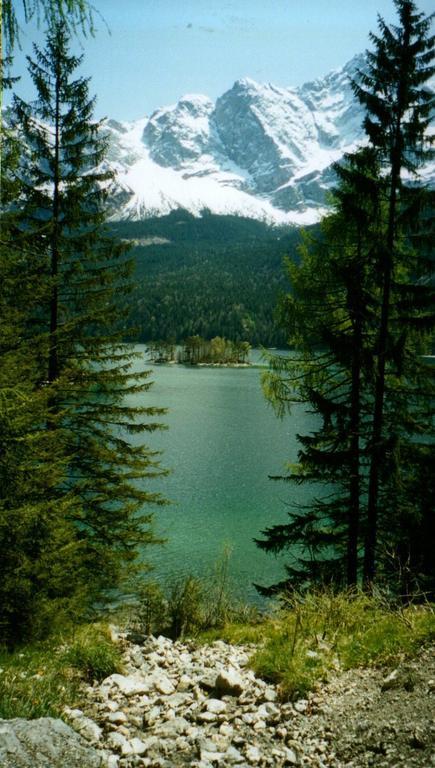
[354,0,435,583]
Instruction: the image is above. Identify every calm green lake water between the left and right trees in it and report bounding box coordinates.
[129,345,313,601]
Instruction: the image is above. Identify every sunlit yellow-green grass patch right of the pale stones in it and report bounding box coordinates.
[201,592,435,699]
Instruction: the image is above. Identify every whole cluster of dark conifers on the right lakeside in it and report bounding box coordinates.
[257,0,435,591]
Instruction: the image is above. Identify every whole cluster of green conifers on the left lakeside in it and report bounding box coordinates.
[0,19,163,639]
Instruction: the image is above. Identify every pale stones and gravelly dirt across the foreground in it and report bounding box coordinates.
[0,637,435,768]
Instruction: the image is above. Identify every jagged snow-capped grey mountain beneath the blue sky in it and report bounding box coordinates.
[107,55,435,224]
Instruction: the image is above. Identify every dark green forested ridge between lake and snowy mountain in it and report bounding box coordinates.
[111,210,306,346]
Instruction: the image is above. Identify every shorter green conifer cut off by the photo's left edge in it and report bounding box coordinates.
[0,103,87,645]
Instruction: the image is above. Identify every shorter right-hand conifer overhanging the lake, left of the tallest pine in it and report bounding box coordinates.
[257,149,383,592]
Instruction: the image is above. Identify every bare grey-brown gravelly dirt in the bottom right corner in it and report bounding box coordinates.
[293,647,435,768]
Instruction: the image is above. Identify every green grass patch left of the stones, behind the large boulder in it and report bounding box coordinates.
[0,624,121,719]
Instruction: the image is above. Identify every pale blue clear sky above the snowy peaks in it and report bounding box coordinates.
[9,0,433,120]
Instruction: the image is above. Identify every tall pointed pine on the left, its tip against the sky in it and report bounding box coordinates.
[10,20,167,616]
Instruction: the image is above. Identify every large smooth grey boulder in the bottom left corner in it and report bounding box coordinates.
[0,717,104,768]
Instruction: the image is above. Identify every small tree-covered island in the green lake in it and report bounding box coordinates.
[147,336,251,367]
